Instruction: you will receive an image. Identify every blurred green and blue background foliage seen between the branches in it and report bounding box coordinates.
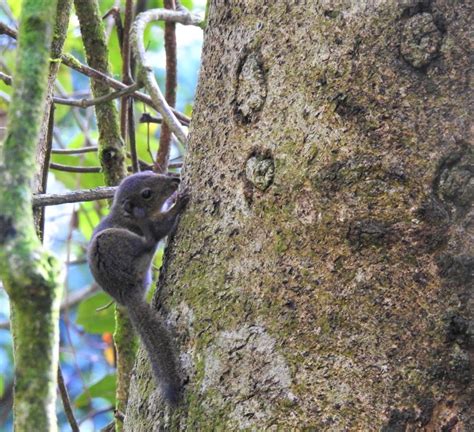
[0,0,206,431]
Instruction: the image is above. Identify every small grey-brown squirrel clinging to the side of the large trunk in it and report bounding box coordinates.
[87,171,189,406]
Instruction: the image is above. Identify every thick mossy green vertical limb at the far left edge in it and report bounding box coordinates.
[0,0,61,431]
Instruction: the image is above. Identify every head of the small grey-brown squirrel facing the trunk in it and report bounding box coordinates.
[113,171,180,219]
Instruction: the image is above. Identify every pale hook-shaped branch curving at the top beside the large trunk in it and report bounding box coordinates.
[131,9,203,144]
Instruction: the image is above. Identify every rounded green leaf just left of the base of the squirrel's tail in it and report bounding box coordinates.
[76,292,115,334]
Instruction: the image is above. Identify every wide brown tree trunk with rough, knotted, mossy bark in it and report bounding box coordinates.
[125,0,474,432]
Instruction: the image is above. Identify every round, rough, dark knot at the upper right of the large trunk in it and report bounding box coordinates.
[400,12,443,69]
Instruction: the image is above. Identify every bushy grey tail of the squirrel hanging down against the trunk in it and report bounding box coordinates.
[128,300,181,406]
